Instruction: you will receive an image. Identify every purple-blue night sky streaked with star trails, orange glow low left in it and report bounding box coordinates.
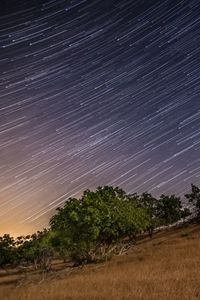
[0,0,200,235]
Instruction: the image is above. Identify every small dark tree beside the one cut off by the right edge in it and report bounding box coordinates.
[157,195,189,225]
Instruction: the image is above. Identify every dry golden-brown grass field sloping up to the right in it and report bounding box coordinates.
[0,225,200,300]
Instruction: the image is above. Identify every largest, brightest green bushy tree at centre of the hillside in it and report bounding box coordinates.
[50,186,149,262]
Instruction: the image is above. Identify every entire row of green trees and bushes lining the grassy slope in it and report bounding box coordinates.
[0,185,200,270]
